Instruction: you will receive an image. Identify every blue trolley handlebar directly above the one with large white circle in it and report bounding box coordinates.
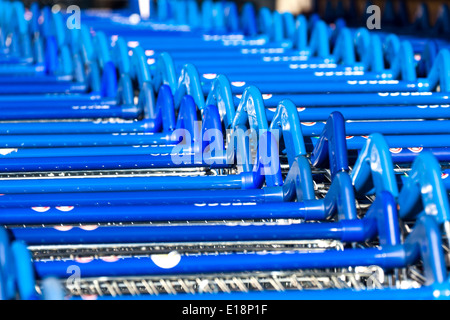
[10,221,366,245]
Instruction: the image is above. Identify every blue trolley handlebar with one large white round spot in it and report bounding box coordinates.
[34,247,406,279]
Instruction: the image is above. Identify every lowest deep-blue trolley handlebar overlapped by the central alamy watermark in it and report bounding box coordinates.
[0,155,228,172]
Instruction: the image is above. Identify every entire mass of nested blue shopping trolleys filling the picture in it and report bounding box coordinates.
[0,0,450,300]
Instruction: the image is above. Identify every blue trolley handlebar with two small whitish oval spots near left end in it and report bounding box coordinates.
[0,202,306,225]
